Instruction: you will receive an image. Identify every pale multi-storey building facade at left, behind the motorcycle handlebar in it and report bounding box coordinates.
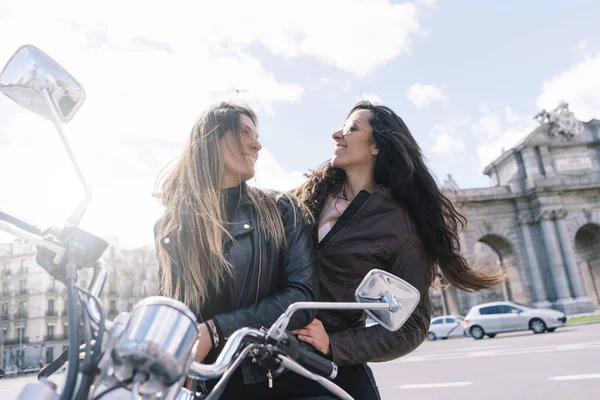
[0,239,158,371]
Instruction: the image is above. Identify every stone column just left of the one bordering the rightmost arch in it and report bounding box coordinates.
[538,210,575,314]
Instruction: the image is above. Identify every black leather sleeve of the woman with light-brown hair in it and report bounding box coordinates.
[213,195,319,337]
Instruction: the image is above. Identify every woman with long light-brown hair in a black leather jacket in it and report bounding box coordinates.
[155,103,318,399]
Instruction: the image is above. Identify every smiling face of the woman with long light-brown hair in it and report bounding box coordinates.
[219,114,262,188]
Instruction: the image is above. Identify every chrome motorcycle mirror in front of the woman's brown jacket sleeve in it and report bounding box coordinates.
[354,269,421,331]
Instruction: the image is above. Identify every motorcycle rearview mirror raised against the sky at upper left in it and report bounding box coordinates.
[0,45,85,123]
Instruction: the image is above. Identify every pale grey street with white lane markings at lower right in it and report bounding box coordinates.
[371,324,600,400]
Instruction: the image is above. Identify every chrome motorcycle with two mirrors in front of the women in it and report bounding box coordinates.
[0,45,420,400]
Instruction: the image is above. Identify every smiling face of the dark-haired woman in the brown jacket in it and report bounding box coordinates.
[331,110,379,171]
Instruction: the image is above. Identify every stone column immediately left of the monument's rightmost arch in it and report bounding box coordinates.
[554,210,594,313]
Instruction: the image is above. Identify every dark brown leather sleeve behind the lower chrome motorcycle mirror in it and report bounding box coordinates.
[329,239,431,365]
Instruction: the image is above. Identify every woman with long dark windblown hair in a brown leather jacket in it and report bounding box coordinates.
[293,102,505,399]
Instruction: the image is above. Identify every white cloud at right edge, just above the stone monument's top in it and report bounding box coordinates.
[537,50,600,121]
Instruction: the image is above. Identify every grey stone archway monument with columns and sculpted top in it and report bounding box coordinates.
[443,103,600,315]
